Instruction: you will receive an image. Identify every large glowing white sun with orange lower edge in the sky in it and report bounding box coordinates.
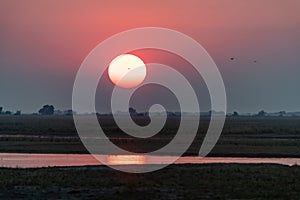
[108,54,146,88]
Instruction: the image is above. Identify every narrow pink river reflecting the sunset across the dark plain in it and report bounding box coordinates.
[0,153,300,168]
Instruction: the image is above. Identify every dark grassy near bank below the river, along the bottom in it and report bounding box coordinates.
[0,164,300,200]
